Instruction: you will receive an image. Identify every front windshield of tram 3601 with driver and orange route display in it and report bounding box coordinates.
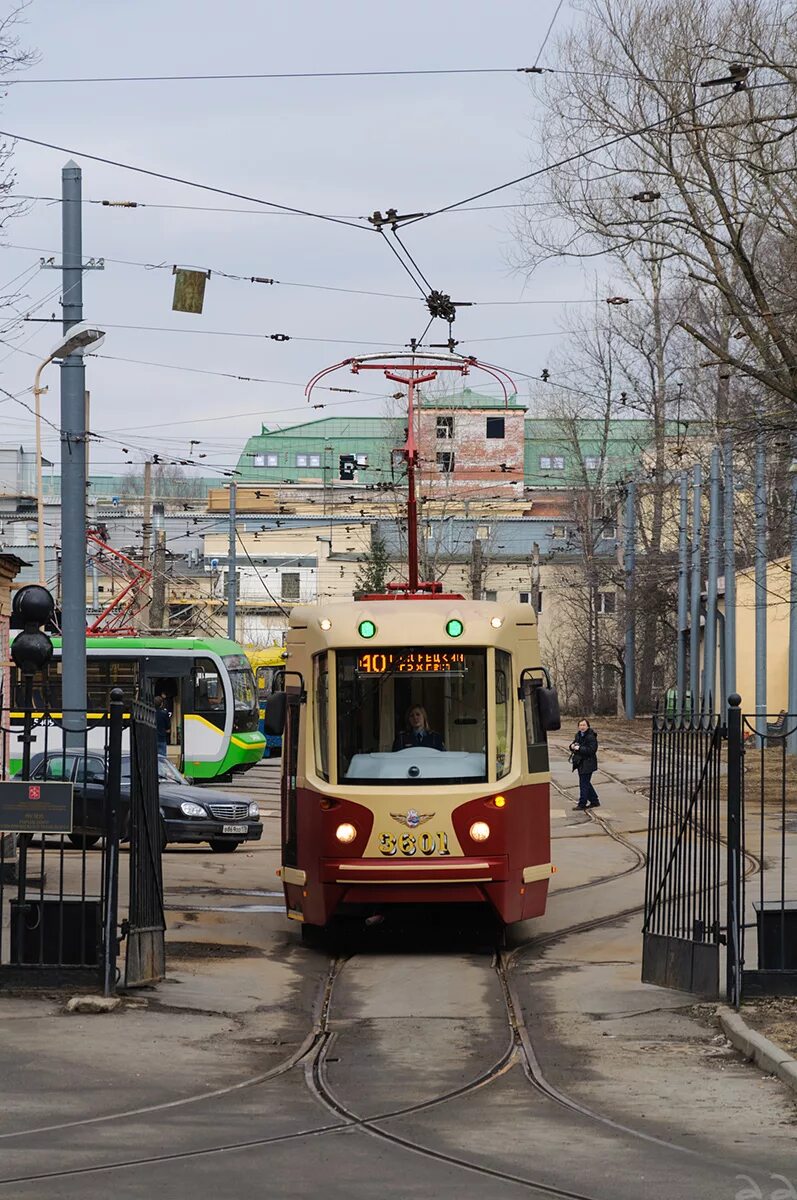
[336,646,487,787]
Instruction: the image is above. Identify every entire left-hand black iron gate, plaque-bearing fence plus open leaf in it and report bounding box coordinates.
[0,690,164,995]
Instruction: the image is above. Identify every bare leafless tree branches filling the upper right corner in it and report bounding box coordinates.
[520,0,797,422]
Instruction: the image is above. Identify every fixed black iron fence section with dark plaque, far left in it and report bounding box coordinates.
[0,691,126,995]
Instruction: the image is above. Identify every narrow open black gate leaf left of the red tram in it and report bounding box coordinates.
[122,701,166,988]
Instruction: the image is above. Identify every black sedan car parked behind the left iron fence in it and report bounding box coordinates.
[17,750,263,854]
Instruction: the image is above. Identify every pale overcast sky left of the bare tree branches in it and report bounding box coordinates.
[0,0,612,487]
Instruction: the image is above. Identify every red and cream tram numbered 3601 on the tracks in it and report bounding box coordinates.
[266,595,559,928]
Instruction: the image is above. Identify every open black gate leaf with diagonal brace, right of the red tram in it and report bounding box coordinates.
[642,714,725,996]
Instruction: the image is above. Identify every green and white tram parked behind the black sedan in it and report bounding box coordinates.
[10,637,265,782]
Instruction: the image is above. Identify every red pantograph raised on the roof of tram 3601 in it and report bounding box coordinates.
[305,348,517,592]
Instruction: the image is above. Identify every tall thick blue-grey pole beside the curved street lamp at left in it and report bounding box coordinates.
[60,161,86,748]
